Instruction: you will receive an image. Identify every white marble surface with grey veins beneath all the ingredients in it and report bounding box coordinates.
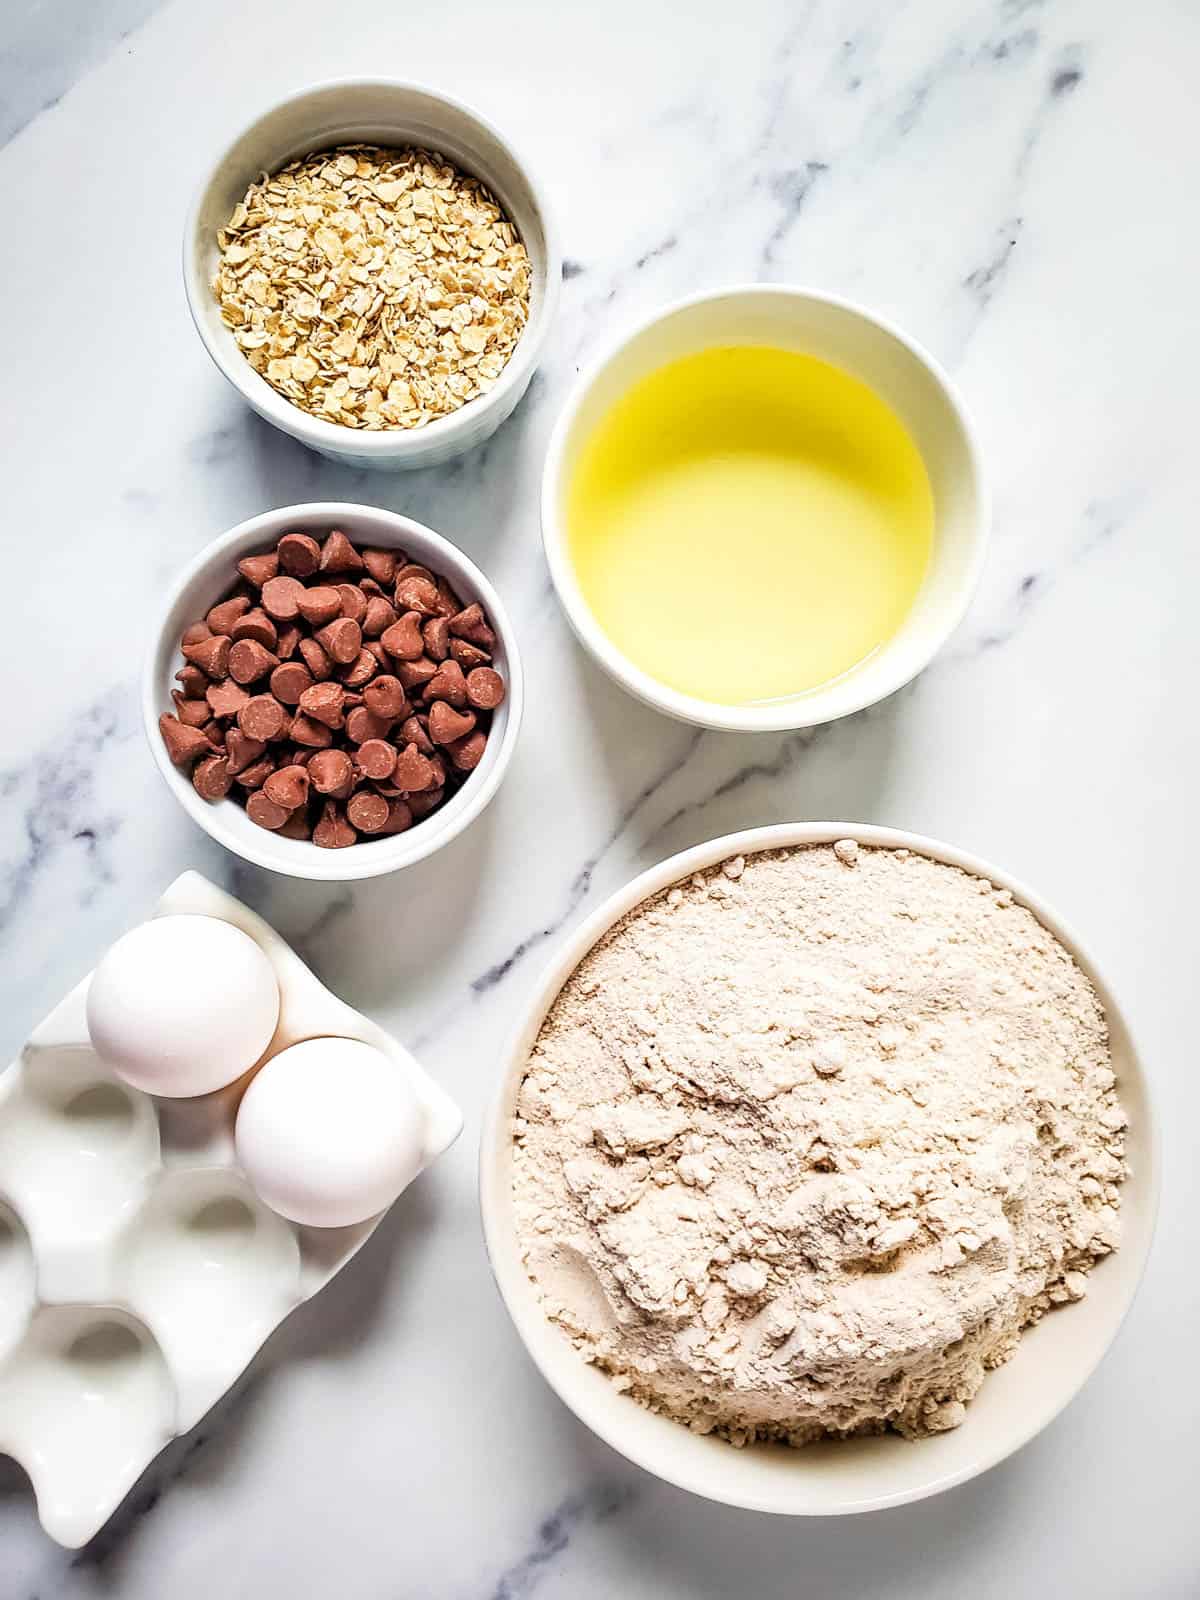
[0,0,1200,1600]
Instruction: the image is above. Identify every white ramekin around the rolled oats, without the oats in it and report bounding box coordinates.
[184,78,562,470]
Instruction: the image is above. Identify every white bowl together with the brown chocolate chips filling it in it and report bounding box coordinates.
[142,502,523,882]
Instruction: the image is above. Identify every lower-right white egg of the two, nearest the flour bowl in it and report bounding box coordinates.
[234,1038,424,1227]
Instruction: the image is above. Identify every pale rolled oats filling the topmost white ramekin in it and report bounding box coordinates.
[213,144,530,430]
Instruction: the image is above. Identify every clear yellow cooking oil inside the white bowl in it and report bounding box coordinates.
[566,346,933,706]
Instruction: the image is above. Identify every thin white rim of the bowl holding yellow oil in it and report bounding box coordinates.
[541,283,990,733]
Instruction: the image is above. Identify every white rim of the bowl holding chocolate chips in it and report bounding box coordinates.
[141,501,525,883]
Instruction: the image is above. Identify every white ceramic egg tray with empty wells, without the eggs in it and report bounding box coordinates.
[0,872,462,1549]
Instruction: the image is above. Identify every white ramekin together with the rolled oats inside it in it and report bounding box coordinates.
[184,78,562,469]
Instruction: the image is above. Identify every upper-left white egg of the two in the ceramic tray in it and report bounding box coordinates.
[88,917,280,1098]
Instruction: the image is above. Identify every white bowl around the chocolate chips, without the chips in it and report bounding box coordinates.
[142,501,525,883]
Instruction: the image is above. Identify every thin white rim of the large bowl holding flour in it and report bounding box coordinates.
[478,822,1162,1517]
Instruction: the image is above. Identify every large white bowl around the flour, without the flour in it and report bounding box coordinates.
[480,822,1158,1517]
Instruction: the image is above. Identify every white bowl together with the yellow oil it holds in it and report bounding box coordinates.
[542,286,987,730]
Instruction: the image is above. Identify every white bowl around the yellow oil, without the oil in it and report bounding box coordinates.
[542,285,987,733]
